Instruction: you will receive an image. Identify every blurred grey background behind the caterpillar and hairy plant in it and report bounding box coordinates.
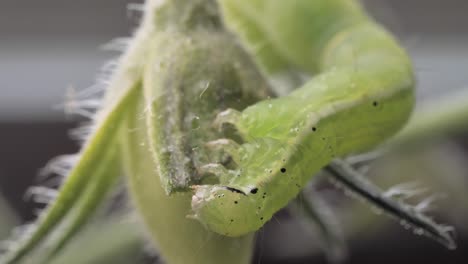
[0,0,468,263]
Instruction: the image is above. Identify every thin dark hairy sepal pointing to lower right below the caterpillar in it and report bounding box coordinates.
[326,160,456,249]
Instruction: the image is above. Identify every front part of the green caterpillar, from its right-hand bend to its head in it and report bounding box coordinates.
[192,1,414,236]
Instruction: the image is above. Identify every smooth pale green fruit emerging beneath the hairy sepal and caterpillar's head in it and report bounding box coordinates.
[120,89,253,264]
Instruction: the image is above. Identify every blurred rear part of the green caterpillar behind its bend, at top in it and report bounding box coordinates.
[218,0,369,74]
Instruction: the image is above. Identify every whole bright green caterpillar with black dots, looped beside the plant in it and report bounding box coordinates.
[192,0,415,236]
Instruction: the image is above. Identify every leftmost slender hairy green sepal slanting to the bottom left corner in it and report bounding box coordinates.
[0,83,138,263]
